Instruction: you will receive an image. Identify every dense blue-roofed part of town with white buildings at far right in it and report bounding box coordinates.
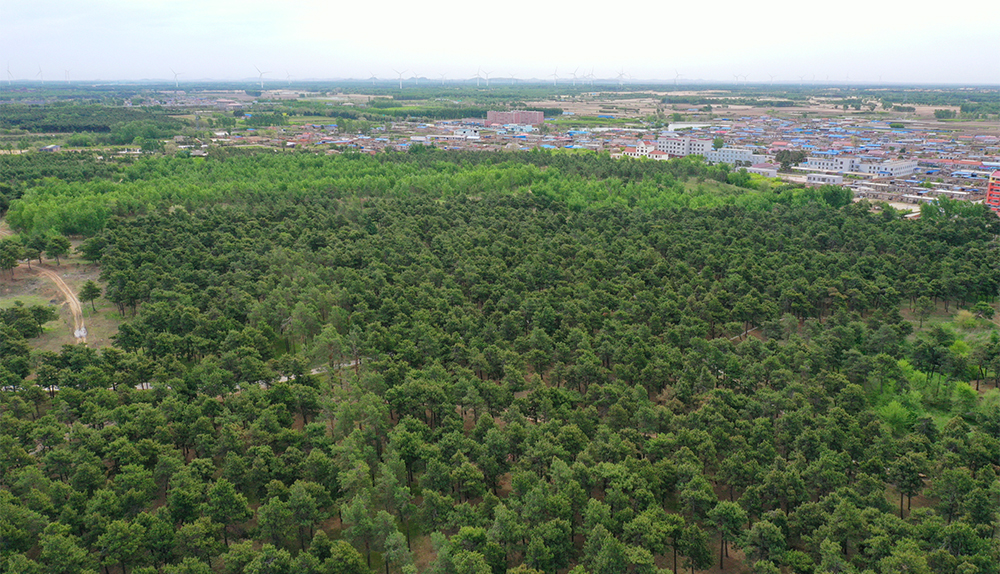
[621,116,1000,206]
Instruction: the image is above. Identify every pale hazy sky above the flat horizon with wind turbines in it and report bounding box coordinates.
[0,0,1000,87]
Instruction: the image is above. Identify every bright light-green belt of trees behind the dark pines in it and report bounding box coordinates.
[0,146,850,235]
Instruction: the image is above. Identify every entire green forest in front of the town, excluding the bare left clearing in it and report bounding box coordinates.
[0,150,1000,574]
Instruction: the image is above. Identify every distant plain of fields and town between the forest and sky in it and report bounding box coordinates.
[0,79,1000,217]
